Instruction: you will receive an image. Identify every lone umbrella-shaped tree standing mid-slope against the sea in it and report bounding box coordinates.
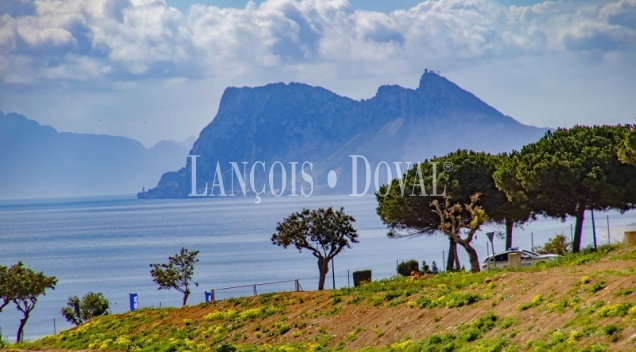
[272,207,358,290]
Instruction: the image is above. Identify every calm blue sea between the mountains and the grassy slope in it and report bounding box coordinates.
[0,196,636,341]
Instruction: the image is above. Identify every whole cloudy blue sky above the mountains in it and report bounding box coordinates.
[0,0,636,146]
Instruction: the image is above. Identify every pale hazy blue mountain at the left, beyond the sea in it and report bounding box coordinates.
[0,112,189,198]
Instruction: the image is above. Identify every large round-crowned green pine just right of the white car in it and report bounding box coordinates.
[494,125,636,252]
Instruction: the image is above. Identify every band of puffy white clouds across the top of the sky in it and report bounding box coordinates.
[0,0,636,84]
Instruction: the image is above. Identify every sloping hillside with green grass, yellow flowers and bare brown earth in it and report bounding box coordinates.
[4,246,636,352]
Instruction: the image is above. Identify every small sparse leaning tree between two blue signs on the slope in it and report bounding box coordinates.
[150,248,199,306]
